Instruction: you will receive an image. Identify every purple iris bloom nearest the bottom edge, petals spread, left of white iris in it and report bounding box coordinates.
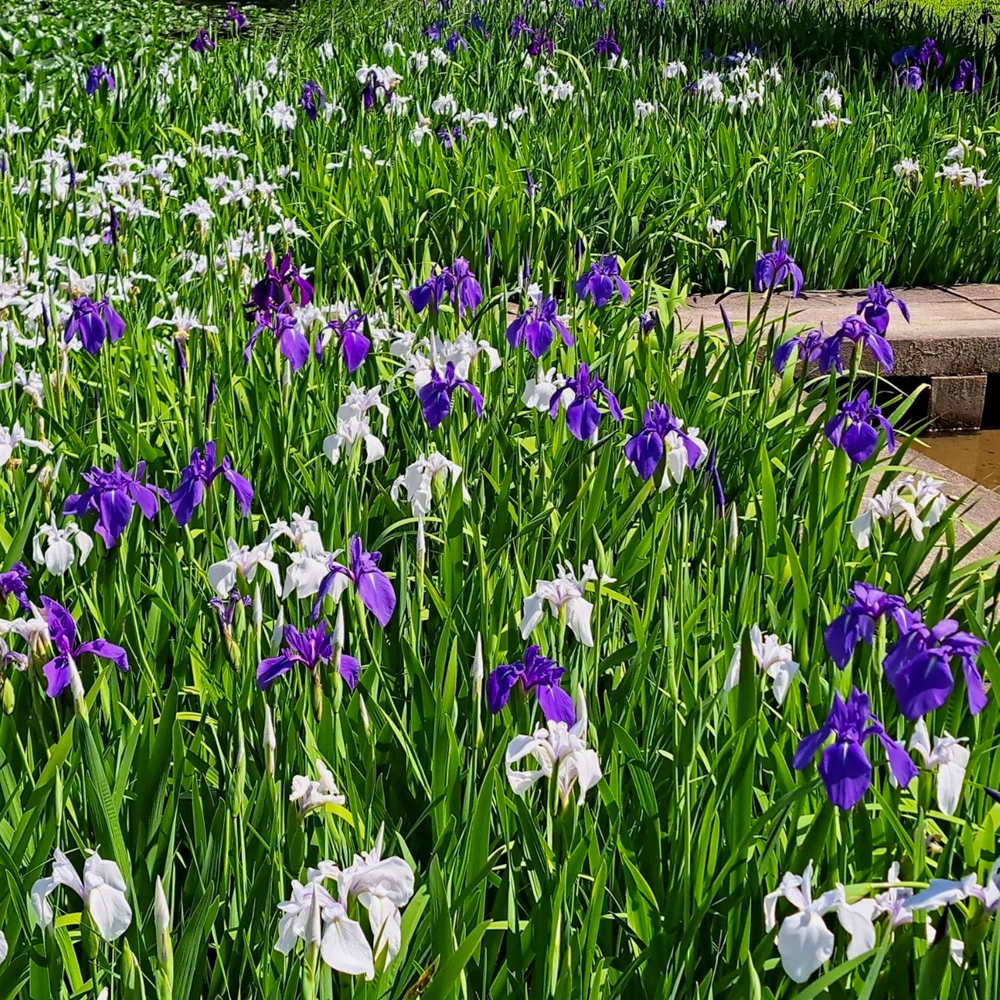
[792,688,917,811]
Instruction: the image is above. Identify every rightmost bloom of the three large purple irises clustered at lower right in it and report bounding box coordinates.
[882,613,986,719]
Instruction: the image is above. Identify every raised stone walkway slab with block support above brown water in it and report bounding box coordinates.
[680,285,1000,430]
